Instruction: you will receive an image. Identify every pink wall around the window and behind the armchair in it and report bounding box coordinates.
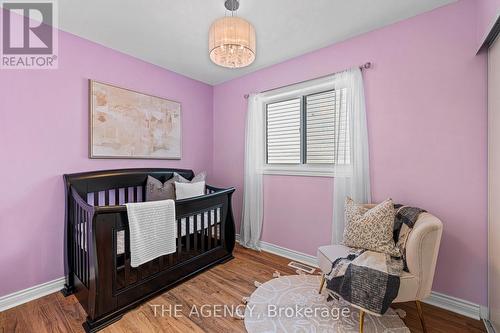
[213,0,487,304]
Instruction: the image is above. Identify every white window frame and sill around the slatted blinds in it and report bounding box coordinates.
[263,85,342,177]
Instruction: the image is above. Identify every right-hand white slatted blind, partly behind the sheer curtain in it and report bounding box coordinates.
[305,89,351,164]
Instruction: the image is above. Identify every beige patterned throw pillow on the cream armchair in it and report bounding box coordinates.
[342,198,401,257]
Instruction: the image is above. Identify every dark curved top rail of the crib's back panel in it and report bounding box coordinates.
[64,168,194,198]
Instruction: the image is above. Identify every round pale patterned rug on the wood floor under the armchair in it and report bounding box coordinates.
[245,275,410,333]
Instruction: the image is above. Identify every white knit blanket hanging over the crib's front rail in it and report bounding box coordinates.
[125,200,177,267]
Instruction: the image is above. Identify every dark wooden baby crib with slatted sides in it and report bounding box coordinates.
[62,169,235,332]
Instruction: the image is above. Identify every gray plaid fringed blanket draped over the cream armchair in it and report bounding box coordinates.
[326,206,424,315]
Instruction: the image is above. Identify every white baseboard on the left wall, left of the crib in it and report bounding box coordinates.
[0,277,66,312]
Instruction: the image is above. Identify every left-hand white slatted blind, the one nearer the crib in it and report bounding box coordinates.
[266,98,301,164]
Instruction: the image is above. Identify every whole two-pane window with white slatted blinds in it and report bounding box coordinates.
[265,88,351,173]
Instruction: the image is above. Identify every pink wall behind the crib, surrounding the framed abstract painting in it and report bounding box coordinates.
[0,33,213,296]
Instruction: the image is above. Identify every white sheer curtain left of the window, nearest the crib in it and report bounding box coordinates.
[240,94,264,250]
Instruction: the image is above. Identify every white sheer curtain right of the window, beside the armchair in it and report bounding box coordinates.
[332,68,371,244]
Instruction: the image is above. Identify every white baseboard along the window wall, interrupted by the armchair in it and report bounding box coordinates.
[236,235,488,320]
